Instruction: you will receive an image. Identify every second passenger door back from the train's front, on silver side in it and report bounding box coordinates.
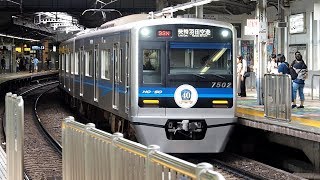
[93,44,100,102]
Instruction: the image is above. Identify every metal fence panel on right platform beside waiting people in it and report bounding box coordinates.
[263,74,292,122]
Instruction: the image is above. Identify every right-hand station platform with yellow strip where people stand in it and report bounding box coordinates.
[236,89,320,142]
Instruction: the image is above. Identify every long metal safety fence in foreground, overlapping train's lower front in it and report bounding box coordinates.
[62,117,224,180]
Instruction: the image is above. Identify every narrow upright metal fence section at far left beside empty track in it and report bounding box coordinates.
[5,93,24,180]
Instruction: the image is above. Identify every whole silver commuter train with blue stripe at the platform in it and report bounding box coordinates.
[59,15,236,153]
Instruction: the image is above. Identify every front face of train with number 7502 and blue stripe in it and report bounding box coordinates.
[132,19,236,153]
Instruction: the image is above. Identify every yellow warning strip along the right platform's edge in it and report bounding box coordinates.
[237,107,320,128]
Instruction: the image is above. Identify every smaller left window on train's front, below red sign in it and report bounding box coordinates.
[143,49,161,84]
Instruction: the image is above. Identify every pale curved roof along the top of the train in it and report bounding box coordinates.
[61,14,234,42]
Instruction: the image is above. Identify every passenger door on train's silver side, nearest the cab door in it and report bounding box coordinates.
[112,43,121,110]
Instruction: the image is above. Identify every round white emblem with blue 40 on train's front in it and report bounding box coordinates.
[174,84,198,109]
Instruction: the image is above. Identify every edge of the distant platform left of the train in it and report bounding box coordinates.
[0,70,58,84]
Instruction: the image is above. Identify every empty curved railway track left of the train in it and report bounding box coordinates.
[4,81,62,179]
